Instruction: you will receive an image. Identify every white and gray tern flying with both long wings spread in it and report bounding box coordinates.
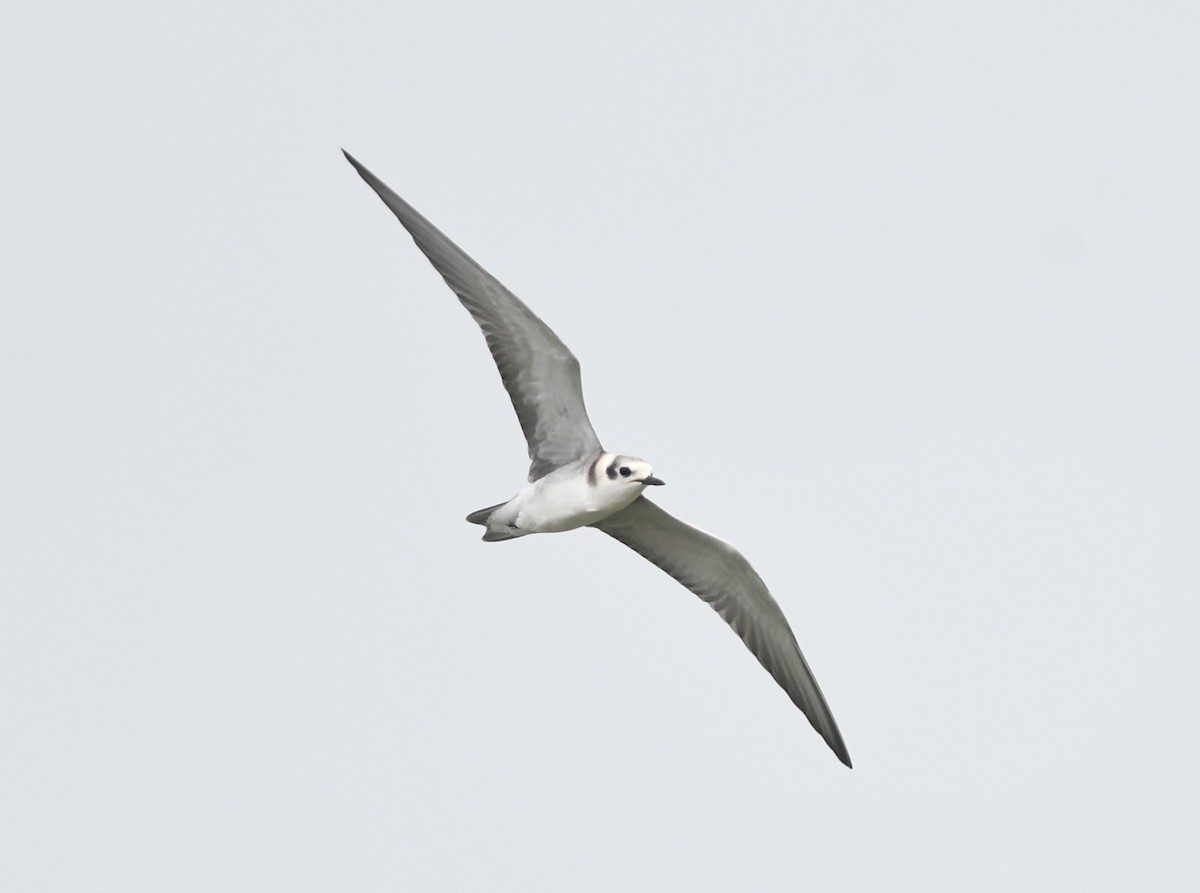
[342,149,853,767]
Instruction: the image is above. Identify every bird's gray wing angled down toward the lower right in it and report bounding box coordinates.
[593,497,851,766]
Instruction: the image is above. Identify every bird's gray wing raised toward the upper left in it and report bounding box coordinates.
[343,150,601,481]
